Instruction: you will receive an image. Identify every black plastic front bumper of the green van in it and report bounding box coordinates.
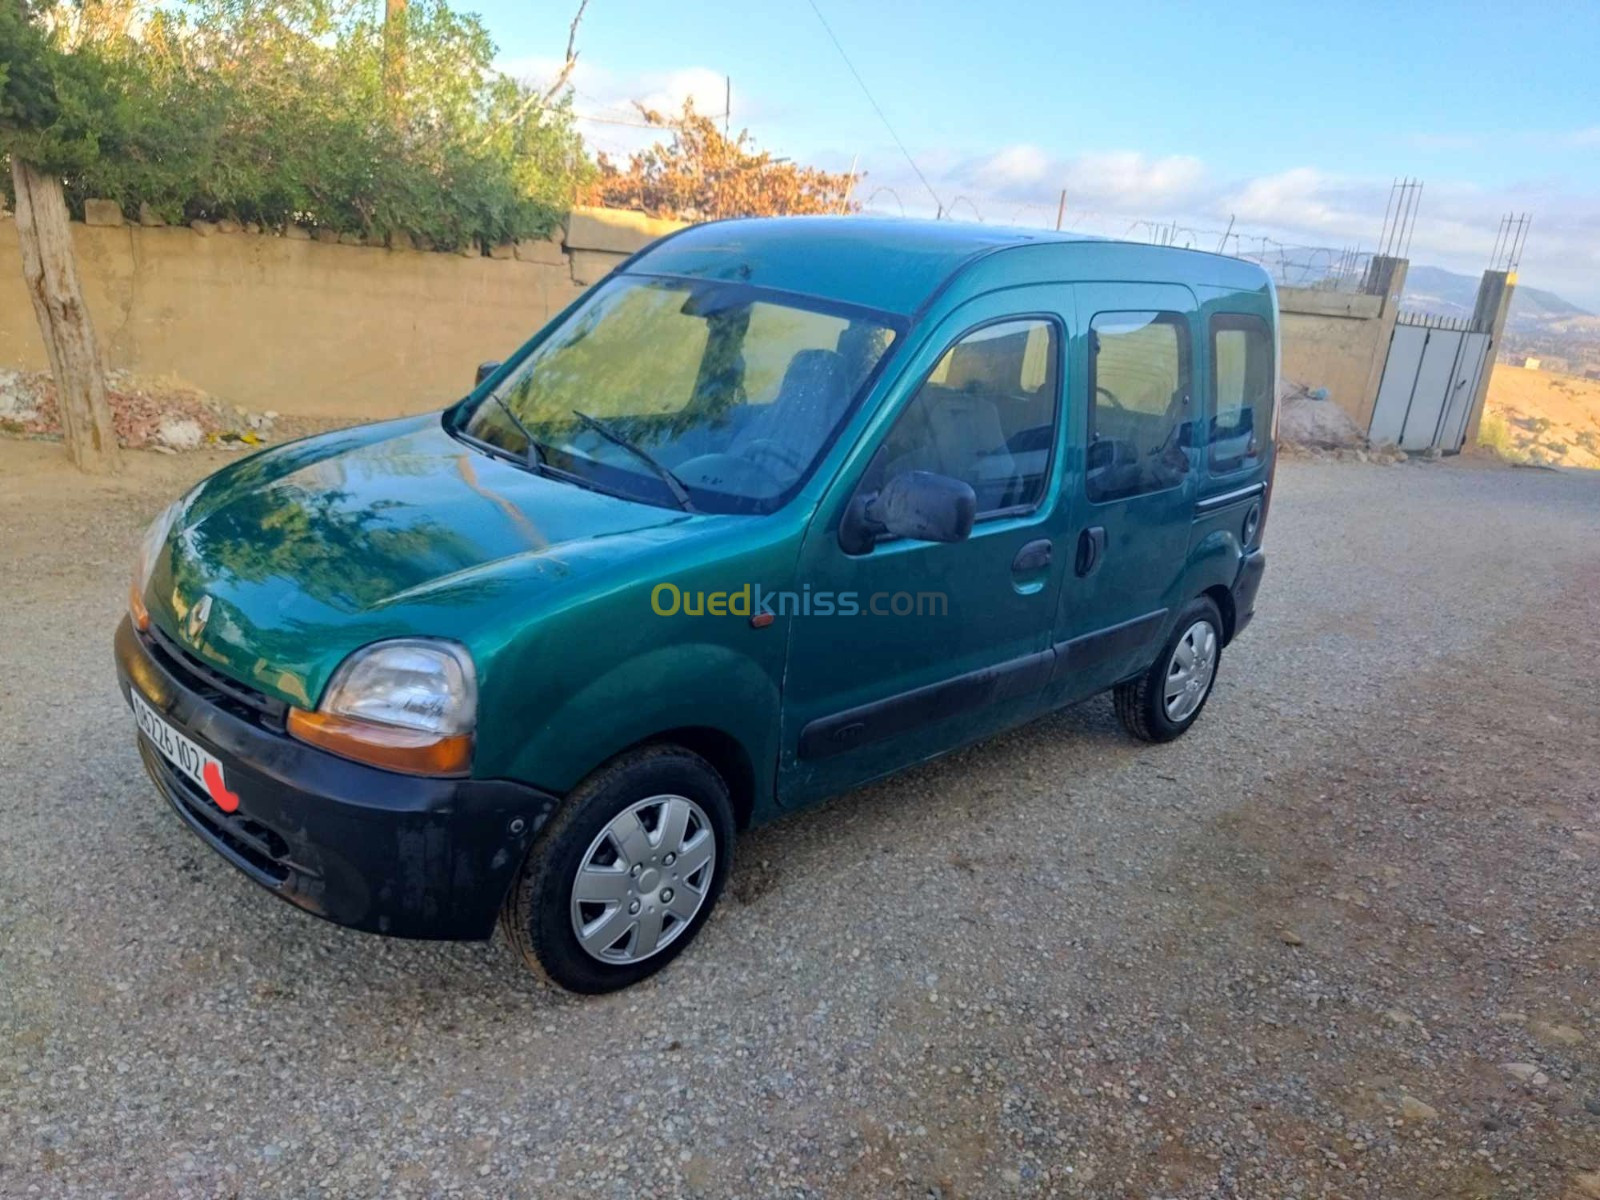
[115,618,557,939]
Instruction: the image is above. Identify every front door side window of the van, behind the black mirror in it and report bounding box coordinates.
[869,317,1061,518]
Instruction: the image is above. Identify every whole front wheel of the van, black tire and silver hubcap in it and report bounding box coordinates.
[501,746,734,992]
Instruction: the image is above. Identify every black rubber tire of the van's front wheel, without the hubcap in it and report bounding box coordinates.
[501,746,734,994]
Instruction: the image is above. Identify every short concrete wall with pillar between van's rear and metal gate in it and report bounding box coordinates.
[1278,258,1408,430]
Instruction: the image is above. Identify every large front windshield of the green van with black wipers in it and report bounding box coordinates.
[458,275,894,512]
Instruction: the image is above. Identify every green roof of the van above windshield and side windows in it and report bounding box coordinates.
[629,216,1270,315]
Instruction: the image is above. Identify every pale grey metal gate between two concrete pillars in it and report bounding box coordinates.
[1366,312,1490,454]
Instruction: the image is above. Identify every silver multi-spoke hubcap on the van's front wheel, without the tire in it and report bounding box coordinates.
[571,795,717,963]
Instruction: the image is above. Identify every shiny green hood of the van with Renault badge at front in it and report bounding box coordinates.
[147,413,694,707]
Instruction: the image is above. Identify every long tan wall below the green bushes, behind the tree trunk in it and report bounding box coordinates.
[0,210,677,418]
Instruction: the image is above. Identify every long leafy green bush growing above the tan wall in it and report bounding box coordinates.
[0,0,592,248]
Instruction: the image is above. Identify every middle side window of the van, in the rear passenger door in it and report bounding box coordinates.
[1085,312,1190,501]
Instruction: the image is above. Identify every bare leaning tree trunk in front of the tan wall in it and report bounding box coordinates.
[11,155,120,474]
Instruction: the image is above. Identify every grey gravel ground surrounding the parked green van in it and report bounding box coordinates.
[0,443,1600,1200]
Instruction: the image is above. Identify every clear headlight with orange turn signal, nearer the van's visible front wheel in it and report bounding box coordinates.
[288,638,478,774]
